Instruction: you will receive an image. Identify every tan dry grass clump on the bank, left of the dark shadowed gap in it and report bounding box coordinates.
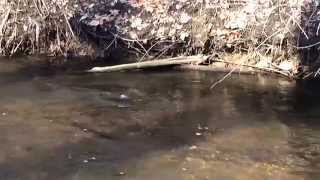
[0,0,81,56]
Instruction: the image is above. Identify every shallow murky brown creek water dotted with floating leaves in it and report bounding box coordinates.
[0,58,320,180]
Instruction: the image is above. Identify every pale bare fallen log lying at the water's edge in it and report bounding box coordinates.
[87,56,209,73]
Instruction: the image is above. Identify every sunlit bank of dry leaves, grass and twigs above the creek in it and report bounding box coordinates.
[0,0,319,74]
